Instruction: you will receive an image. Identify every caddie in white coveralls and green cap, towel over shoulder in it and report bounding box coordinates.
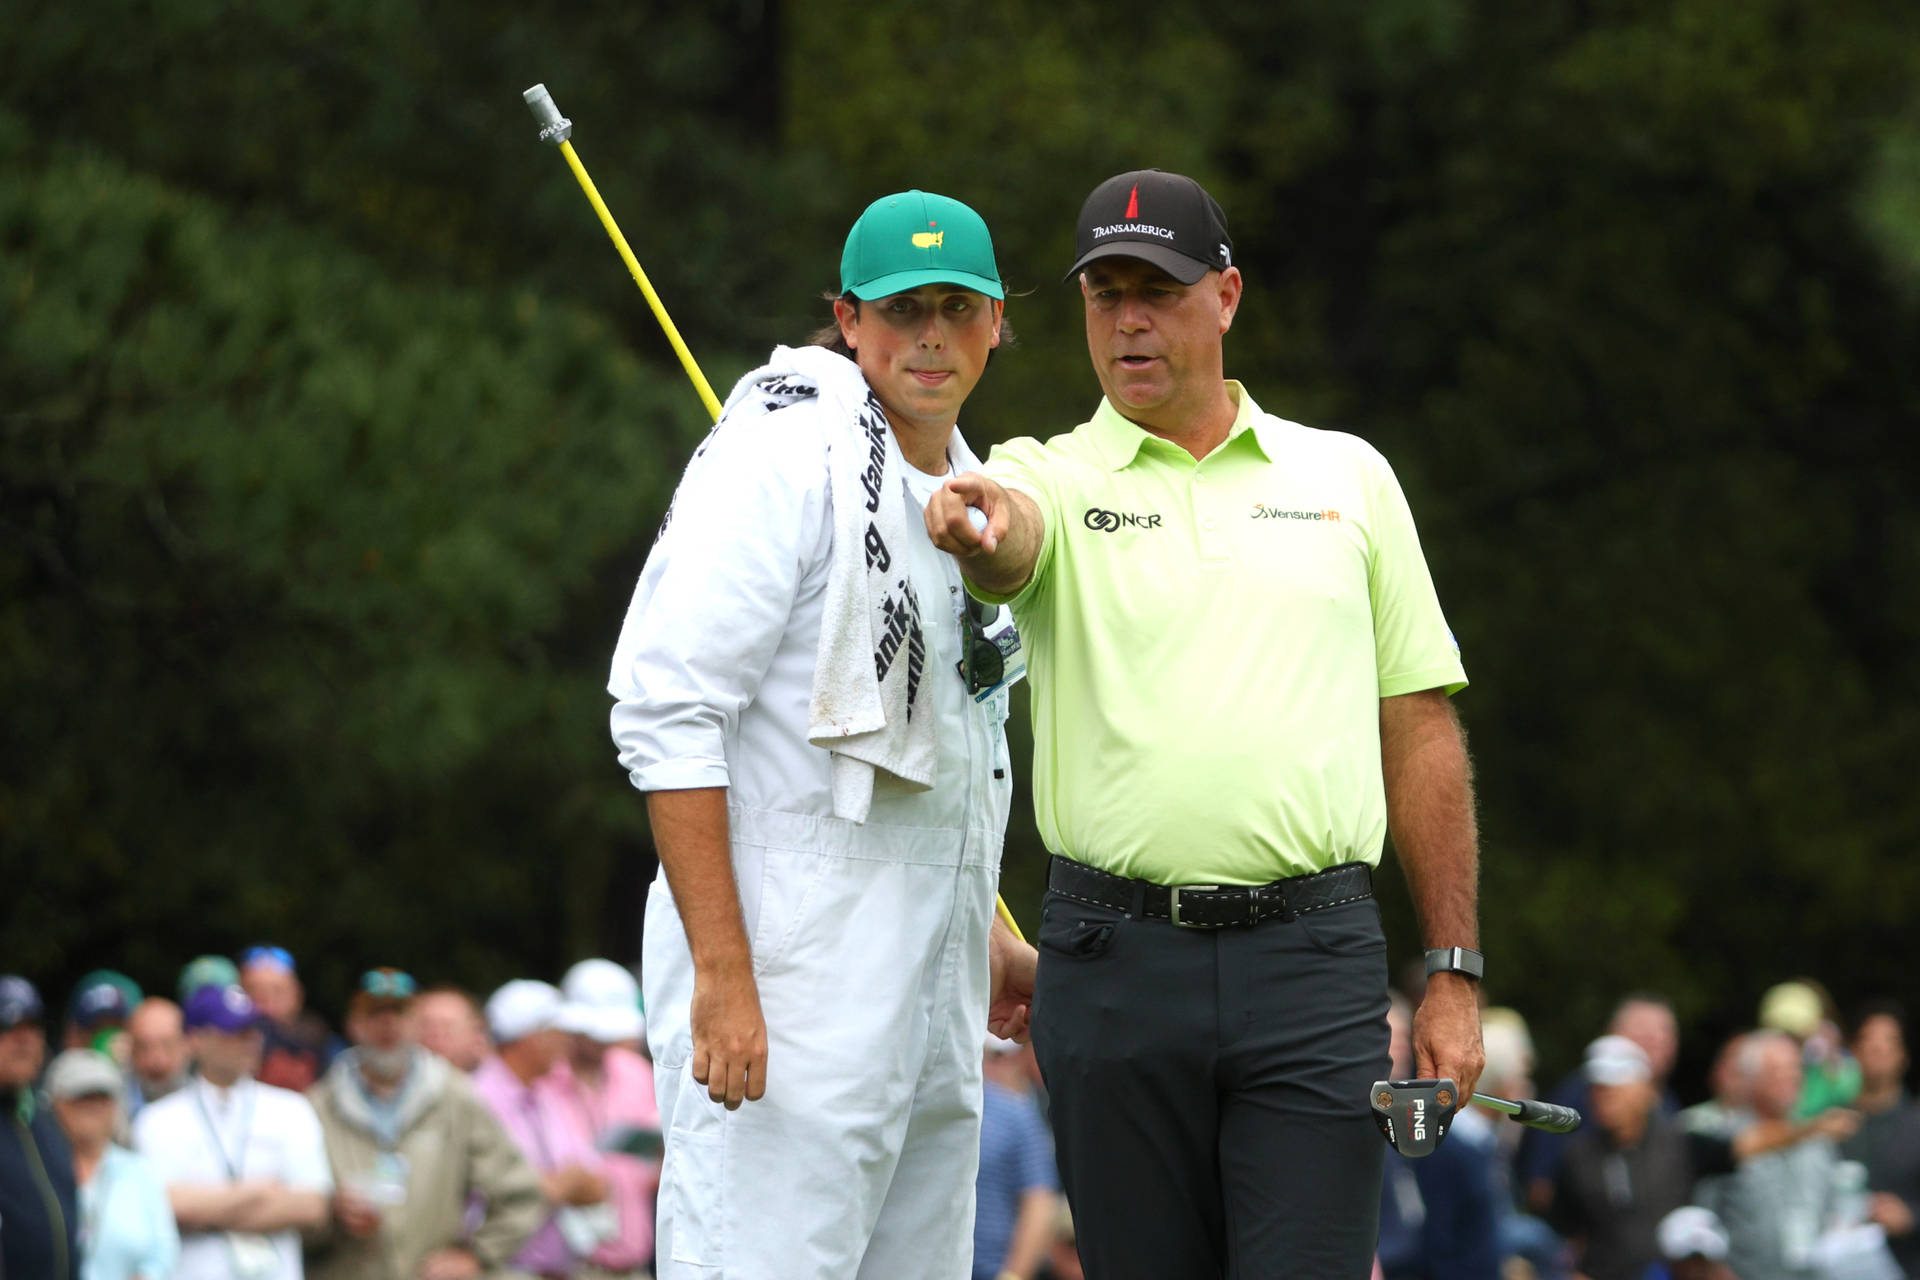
[611,192,1035,1280]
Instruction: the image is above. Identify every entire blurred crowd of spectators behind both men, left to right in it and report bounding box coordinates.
[0,946,1920,1280]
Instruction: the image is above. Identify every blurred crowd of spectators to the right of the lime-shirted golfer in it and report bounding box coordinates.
[1379,979,1920,1280]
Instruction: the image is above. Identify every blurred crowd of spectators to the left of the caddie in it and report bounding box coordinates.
[0,946,660,1280]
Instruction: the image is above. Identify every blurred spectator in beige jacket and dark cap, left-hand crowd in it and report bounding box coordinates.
[309,969,545,1280]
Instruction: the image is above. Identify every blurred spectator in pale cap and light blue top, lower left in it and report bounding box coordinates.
[46,1050,180,1280]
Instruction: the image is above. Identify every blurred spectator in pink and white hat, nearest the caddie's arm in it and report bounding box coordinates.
[540,960,660,1280]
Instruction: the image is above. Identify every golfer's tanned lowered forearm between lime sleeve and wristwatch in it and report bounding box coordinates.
[1380,689,1480,948]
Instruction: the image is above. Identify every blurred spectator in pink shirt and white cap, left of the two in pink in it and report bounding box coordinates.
[472,979,616,1276]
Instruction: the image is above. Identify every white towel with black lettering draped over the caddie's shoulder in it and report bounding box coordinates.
[714,347,936,821]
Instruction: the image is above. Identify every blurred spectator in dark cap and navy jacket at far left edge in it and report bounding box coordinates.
[0,973,81,1280]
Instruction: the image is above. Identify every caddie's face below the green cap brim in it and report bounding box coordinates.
[833,284,1004,430]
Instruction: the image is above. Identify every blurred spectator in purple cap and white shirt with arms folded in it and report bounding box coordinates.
[134,986,334,1280]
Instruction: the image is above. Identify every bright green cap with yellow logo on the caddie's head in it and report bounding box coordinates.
[841,192,1006,301]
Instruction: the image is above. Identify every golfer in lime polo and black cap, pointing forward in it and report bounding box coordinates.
[927,169,1482,1280]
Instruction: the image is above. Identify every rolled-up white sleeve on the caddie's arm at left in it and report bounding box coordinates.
[607,407,831,791]
